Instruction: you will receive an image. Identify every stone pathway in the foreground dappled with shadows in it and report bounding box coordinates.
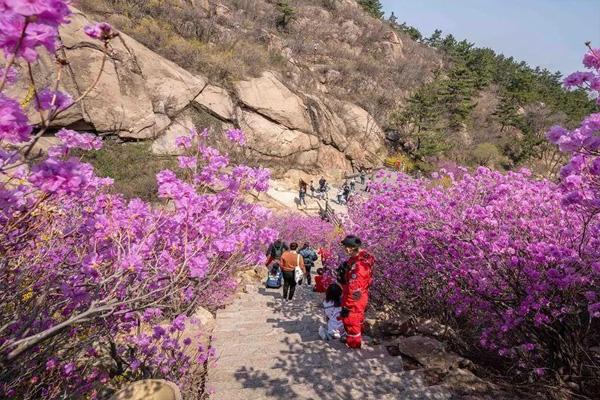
[208,278,451,400]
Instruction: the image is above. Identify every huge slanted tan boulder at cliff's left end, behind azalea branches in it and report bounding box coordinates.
[9,9,206,139]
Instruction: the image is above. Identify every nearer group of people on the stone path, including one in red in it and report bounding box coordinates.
[267,235,375,348]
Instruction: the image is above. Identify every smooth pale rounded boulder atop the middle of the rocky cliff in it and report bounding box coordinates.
[235,72,312,133]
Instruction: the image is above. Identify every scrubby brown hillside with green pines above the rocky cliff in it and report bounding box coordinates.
[79,0,593,174]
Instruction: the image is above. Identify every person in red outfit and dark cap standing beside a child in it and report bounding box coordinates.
[338,235,375,349]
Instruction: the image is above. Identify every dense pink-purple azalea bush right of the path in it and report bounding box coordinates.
[348,49,600,395]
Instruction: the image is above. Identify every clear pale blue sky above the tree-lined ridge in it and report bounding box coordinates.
[381,0,600,74]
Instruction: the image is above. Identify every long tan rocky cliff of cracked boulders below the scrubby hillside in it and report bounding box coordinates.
[13,5,394,175]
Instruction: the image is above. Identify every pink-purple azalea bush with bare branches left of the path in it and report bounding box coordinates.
[0,0,275,399]
